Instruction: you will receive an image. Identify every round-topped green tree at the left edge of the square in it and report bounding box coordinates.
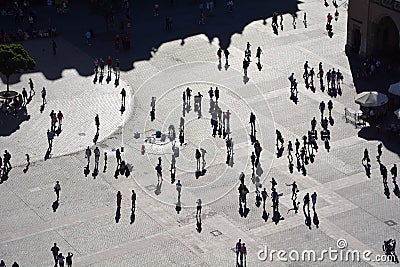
[0,44,36,92]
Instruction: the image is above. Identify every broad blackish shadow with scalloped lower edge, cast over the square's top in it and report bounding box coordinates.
[0,0,302,85]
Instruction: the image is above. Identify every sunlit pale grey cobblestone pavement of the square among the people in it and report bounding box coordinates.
[0,0,400,266]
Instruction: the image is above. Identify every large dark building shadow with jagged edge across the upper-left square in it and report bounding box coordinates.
[0,0,300,83]
